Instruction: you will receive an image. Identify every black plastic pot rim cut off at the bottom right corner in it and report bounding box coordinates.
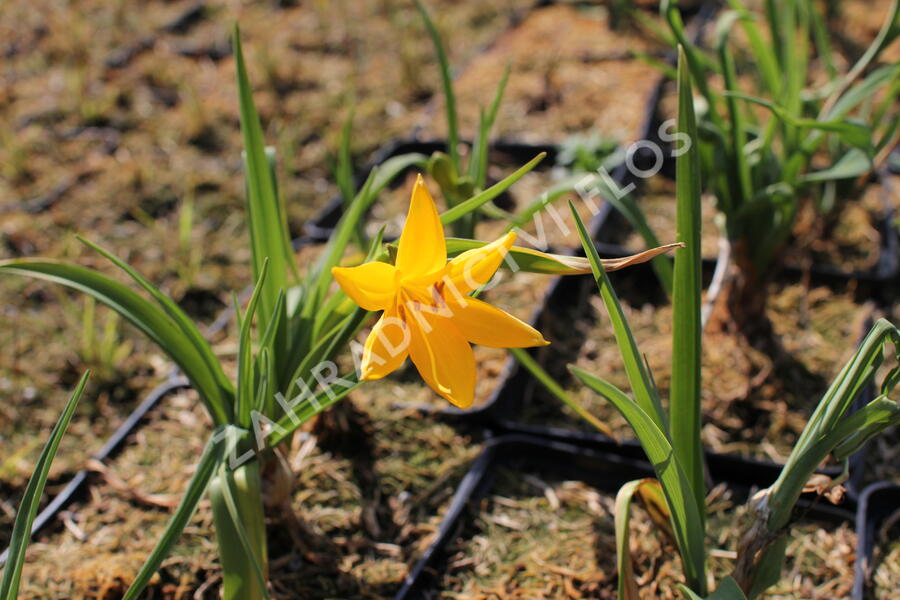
[853,481,900,600]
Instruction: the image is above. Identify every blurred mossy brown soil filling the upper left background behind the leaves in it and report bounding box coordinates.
[0,0,531,488]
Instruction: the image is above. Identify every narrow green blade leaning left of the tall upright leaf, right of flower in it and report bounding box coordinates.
[569,201,669,435]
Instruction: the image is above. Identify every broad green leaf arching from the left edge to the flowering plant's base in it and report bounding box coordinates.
[0,259,232,425]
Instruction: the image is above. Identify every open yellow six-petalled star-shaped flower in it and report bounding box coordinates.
[332,175,549,408]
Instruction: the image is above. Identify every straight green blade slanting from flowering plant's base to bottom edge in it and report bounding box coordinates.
[123,428,222,600]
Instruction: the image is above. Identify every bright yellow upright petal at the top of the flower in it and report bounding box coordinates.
[396,175,447,279]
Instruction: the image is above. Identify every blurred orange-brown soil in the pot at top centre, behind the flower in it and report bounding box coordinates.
[425,5,667,142]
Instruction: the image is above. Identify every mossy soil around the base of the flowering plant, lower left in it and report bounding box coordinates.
[12,386,486,600]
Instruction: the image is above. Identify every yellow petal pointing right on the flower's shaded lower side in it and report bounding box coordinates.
[448,298,550,348]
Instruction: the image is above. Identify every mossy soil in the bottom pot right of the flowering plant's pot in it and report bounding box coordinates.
[439,467,856,600]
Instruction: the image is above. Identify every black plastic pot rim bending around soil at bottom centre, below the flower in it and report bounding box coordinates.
[394,435,853,600]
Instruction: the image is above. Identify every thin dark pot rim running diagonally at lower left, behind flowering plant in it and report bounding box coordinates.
[0,370,189,568]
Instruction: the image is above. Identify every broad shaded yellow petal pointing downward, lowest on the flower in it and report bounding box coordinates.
[404,307,475,408]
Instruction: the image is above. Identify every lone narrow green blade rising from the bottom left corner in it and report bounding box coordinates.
[0,371,91,600]
